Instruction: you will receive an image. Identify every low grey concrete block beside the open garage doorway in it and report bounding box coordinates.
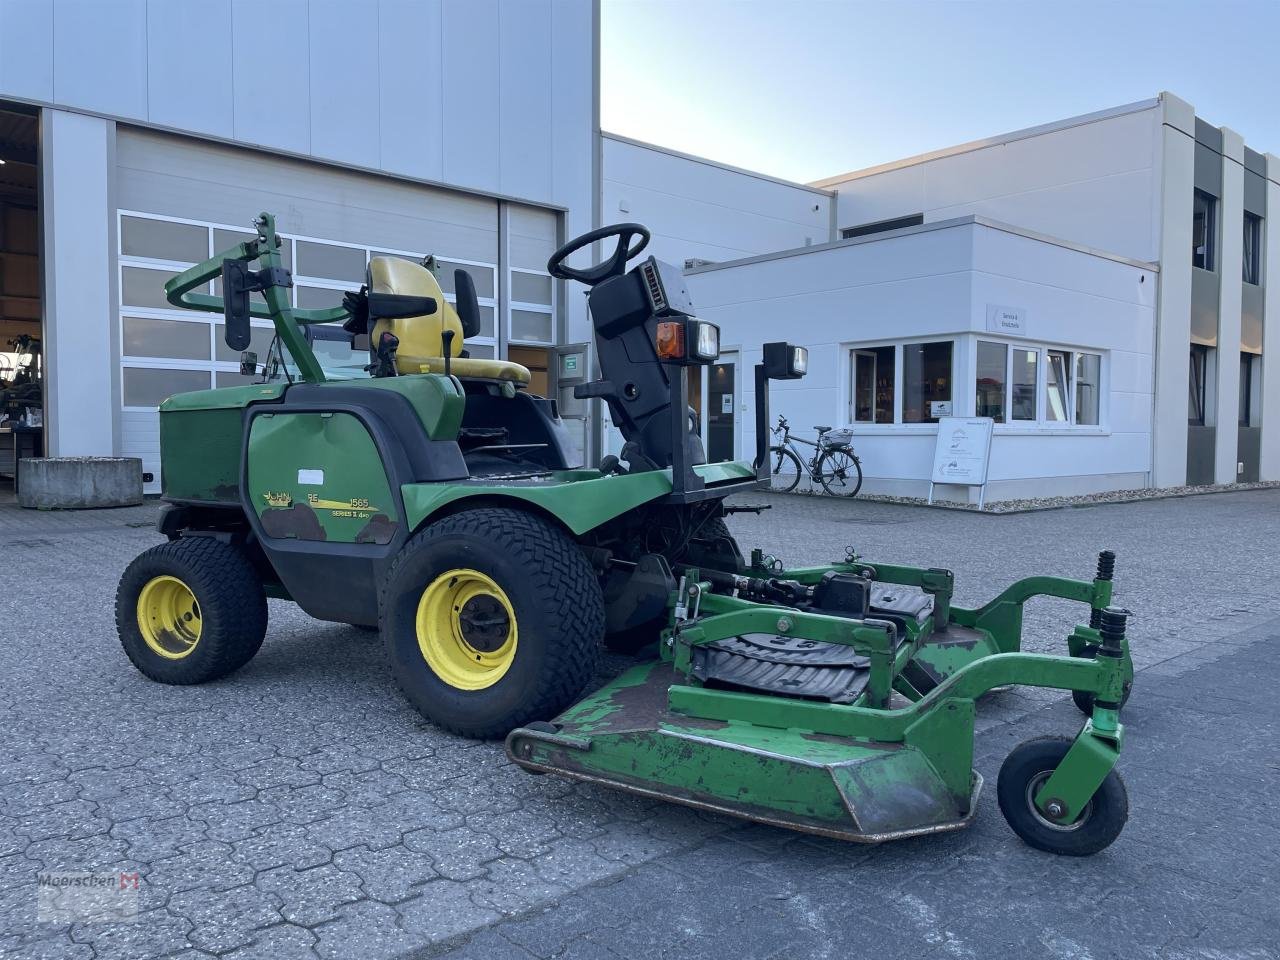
[18,457,142,509]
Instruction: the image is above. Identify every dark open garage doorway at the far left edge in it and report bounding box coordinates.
[0,102,44,498]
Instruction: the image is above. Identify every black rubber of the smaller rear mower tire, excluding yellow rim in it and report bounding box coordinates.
[115,536,266,685]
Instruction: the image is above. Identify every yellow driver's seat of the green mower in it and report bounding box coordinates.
[367,257,530,387]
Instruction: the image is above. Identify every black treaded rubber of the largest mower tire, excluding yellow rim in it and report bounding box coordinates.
[379,507,604,740]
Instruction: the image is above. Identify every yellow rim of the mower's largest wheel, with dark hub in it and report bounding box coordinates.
[416,567,517,690]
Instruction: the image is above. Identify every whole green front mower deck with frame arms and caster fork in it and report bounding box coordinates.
[507,554,1129,852]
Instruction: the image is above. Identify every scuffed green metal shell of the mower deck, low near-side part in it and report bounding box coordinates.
[507,662,982,844]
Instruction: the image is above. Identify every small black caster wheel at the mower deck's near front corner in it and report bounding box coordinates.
[996,737,1129,856]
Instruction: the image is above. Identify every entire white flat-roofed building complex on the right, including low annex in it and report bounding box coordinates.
[603,93,1280,498]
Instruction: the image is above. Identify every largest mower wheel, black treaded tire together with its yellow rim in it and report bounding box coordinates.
[380,507,604,739]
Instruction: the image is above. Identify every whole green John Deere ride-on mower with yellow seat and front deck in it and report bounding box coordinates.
[116,214,1133,855]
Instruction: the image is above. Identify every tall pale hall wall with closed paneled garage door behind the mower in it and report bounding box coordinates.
[0,0,599,489]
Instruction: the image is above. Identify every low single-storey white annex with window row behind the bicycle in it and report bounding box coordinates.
[689,216,1156,499]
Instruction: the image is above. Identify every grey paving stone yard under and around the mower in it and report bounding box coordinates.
[0,492,1280,960]
